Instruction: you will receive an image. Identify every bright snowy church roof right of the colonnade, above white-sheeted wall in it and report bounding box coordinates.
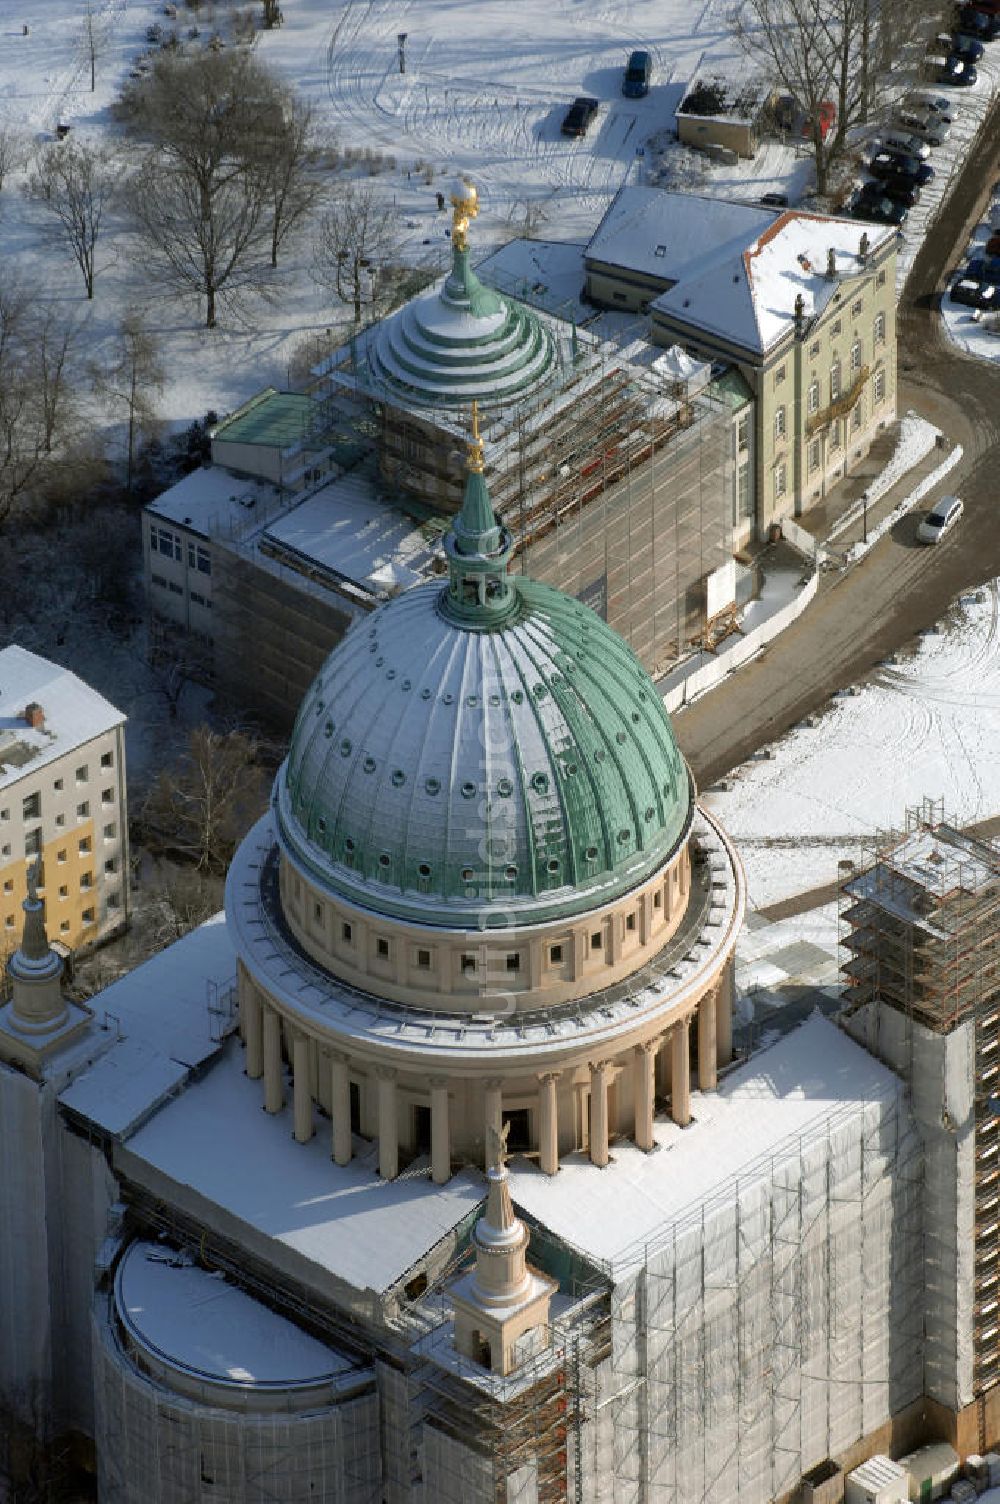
[510,1014,902,1266]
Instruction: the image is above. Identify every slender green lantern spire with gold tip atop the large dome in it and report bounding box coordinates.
[442,402,517,630]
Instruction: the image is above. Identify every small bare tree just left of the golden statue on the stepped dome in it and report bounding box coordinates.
[313,183,398,323]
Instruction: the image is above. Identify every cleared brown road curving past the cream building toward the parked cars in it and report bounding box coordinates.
[674,85,1000,793]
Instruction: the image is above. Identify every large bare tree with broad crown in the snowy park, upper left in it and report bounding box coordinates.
[132,51,286,329]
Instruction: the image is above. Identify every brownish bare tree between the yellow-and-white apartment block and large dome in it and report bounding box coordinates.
[140,726,266,872]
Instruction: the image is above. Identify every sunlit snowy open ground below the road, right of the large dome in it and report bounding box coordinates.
[705,581,1000,910]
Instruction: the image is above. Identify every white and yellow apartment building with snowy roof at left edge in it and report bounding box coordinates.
[0,647,129,954]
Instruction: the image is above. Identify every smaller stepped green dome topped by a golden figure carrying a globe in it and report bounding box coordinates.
[368,182,555,406]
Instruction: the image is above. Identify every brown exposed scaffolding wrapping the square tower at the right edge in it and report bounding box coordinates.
[841,799,1000,1397]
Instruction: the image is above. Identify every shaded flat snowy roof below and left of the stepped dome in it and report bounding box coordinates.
[262,471,441,596]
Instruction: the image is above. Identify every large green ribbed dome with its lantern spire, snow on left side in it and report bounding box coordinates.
[275,415,693,929]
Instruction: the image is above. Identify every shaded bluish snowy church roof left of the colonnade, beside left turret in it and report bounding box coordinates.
[60,914,236,1136]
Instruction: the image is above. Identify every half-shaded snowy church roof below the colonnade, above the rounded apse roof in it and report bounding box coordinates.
[117,1041,486,1292]
